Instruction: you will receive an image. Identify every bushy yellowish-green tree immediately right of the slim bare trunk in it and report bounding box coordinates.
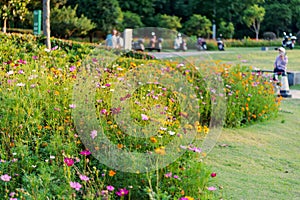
[51,6,96,38]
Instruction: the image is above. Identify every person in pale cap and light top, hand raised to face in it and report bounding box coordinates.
[273,47,288,81]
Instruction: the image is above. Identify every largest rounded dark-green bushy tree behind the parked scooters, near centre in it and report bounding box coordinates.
[183,14,212,37]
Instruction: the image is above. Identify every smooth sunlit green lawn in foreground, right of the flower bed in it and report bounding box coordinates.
[206,99,300,200]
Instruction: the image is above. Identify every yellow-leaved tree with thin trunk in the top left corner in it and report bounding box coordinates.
[0,0,30,33]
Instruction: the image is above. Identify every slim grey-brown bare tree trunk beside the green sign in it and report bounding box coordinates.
[43,0,51,49]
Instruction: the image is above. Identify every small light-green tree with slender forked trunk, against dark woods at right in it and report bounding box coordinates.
[243,4,266,40]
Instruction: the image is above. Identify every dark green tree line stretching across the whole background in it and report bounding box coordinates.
[0,0,300,38]
